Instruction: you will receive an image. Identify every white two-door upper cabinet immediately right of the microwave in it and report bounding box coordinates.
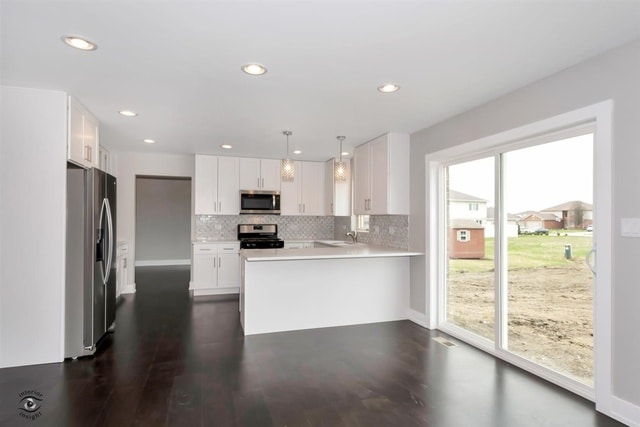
[280,162,325,216]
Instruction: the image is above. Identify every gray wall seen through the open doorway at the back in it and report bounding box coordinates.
[136,177,191,264]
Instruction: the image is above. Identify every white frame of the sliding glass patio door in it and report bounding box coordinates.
[425,100,613,416]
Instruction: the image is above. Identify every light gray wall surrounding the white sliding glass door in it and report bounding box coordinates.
[409,40,640,407]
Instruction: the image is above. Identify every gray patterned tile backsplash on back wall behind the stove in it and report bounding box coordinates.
[194,215,334,240]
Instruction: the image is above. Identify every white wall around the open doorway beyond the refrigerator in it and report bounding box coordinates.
[117,152,195,289]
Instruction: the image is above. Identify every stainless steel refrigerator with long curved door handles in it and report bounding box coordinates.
[65,163,116,358]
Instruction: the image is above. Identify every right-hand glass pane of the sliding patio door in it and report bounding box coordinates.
[503,135,593,385]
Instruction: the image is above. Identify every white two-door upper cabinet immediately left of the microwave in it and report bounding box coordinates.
[194,154,240,215]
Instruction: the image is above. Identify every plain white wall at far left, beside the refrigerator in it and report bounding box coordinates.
[0,87,67,368]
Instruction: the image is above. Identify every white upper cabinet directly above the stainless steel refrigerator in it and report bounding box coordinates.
[67,97,99,168]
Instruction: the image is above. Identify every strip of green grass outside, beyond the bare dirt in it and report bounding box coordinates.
[449,231,592,273]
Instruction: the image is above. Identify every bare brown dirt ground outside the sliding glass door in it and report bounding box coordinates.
[448,262,593,385]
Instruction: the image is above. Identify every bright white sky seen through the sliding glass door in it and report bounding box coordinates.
[449,135,593,214]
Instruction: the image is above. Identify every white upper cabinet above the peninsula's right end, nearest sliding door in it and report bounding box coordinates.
[354,133,409,215]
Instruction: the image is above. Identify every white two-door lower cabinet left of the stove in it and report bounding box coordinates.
[189,242,241,296]
